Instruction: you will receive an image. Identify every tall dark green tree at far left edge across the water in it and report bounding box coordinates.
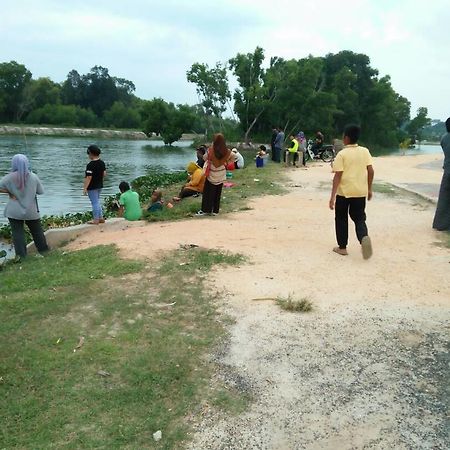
[0,61,31,122]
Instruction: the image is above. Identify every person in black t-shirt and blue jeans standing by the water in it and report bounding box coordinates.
[83,145,106,225]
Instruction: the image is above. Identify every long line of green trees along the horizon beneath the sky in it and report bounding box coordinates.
[0,47,430,147]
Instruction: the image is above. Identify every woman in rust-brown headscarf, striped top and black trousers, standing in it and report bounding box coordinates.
[197,133,234,216]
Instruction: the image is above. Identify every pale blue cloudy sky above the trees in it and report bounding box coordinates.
[0,0,450,120]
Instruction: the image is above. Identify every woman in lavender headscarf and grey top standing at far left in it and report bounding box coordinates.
[0,154,49,258]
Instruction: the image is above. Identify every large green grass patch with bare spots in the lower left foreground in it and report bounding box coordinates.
[0,247,243,449]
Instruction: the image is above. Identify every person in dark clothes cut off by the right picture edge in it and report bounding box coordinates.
[433,117,450,231]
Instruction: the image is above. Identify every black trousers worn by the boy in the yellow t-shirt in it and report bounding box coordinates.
[334,195,368,248]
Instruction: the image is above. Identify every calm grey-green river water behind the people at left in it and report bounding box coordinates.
[0,136,196,223]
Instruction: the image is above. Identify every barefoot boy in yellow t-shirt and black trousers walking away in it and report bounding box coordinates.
[329,125,374,259]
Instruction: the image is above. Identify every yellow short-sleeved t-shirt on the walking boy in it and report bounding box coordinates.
[333,144,372,198]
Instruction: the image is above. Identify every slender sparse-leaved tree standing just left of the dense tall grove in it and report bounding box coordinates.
[186,63,231,134]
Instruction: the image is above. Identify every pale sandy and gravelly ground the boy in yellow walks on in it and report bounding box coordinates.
[70,155,450,449]
